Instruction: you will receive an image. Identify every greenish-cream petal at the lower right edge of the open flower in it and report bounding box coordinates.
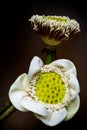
[65,95,80,121]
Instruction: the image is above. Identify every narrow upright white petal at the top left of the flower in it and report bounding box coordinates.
[28,56,43,81]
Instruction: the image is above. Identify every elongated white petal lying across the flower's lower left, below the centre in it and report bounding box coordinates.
[21,97,48,116]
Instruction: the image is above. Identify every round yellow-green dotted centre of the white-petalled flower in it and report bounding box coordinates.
[36,72,66,104]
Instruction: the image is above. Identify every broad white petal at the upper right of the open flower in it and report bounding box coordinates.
[51,59,77,75]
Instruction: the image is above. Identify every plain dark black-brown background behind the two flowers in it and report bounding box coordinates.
[0,0,87,130]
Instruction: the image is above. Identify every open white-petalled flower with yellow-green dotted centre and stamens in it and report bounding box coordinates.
[9,56,80,126]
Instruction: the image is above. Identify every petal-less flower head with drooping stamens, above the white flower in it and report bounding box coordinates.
[29,15,80,47]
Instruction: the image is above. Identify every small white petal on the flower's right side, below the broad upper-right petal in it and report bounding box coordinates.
[69,73,80,94]
